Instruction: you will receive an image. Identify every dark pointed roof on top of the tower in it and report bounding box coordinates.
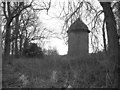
[68,18,90,32]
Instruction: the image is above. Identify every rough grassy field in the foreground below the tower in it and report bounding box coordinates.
[3,53,114,88]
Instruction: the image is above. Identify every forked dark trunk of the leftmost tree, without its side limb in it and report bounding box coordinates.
[3,2,13,63]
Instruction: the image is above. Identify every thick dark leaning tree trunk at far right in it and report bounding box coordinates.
[100,2,119,87]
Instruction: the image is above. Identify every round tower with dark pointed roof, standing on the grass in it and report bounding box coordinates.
[67,18,90,57]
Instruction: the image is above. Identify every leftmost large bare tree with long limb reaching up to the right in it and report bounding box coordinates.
[2,2,31,60]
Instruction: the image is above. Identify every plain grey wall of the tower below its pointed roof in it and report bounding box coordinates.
[68,29,89,57]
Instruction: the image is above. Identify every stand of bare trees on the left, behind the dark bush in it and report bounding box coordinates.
[1,0,51,60]
